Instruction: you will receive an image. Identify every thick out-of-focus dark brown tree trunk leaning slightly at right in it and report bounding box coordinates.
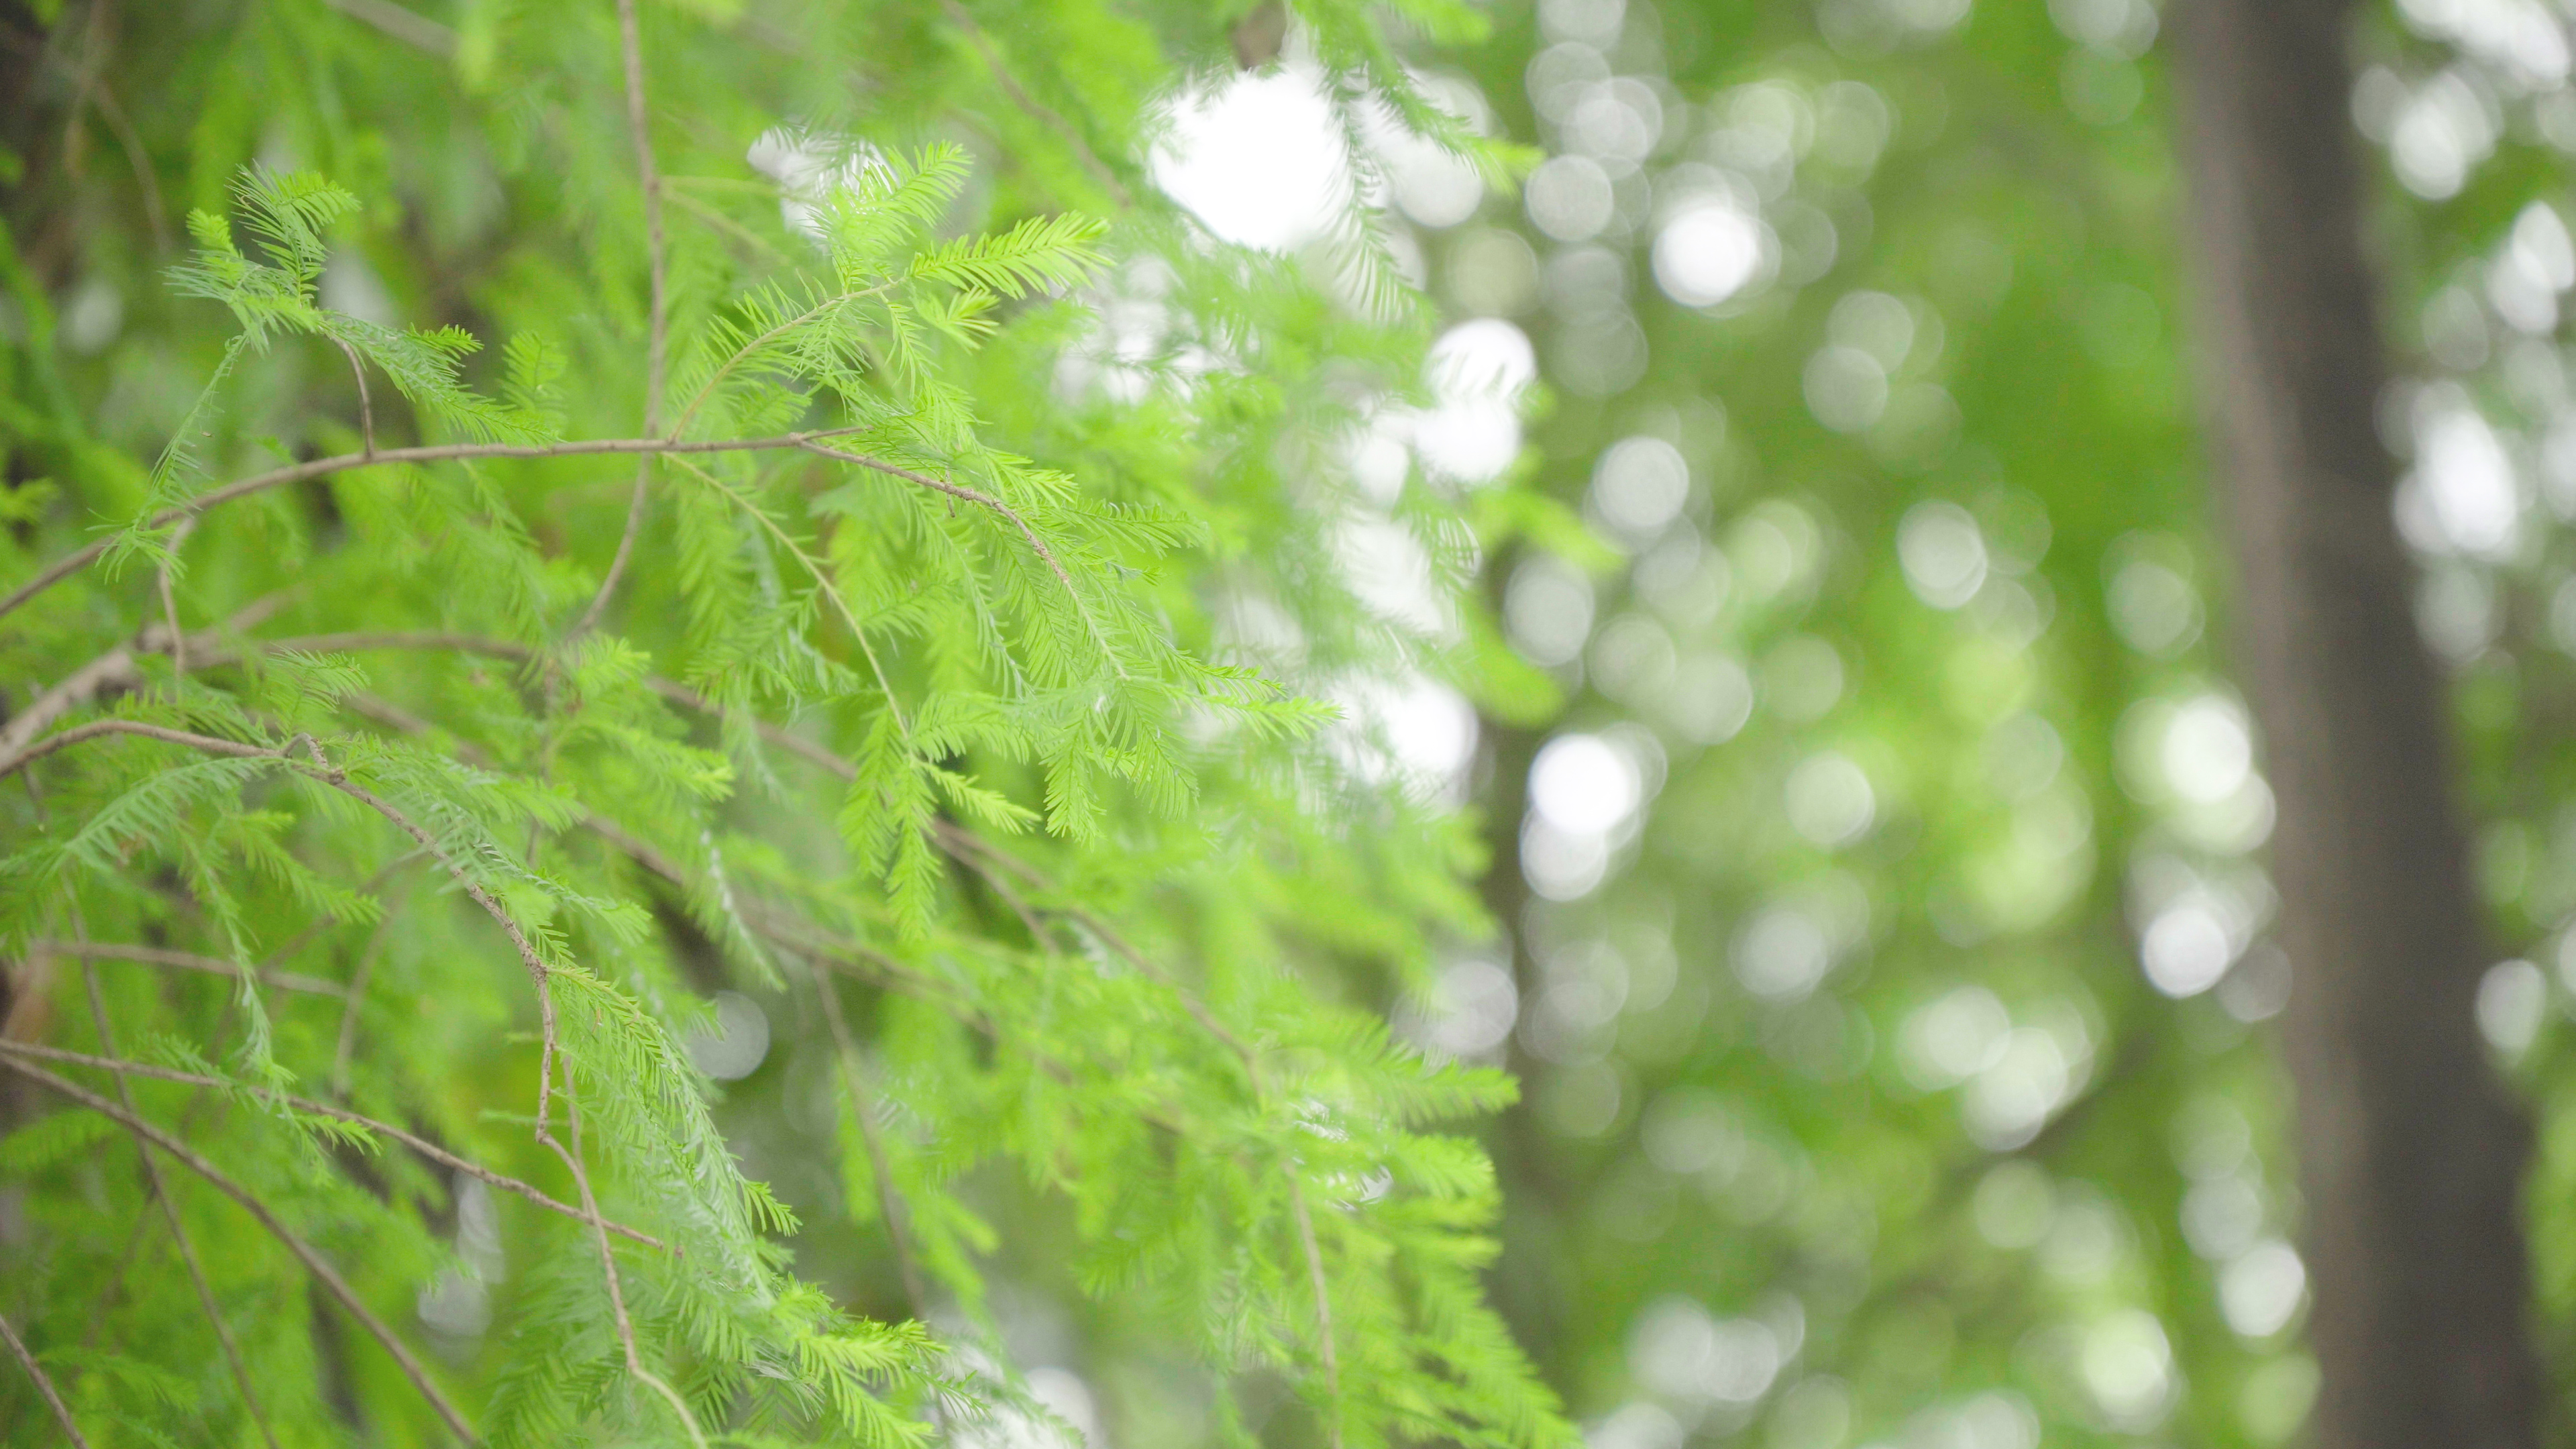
[2174,0,2537,1449]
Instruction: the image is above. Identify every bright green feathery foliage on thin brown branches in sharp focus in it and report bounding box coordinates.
[0,0,1569,1449]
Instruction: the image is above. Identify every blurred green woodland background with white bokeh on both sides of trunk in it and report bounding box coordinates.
[1393,0,2576,1449]
